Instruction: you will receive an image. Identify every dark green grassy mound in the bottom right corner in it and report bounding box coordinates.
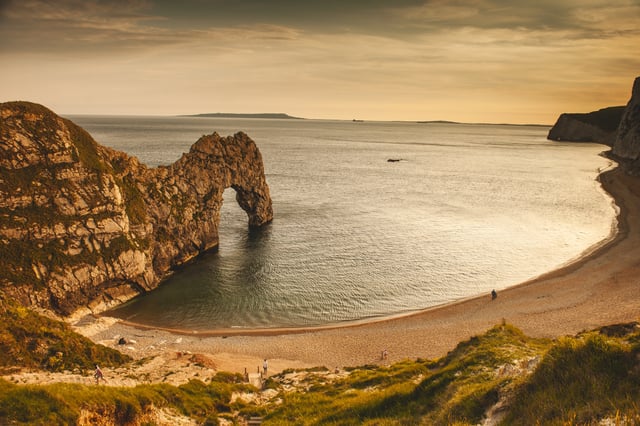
[507,332,640,425]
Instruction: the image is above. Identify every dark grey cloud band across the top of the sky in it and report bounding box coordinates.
[0,0,640,55]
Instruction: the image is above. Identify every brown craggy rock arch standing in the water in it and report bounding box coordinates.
[147,132,273,272]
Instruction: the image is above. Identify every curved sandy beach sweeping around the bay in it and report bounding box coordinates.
[74,168,640,373]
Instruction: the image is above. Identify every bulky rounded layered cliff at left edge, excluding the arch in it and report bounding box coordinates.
[0,102,148,314]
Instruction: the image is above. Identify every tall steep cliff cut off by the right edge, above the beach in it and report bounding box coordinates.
[612,77,640,162]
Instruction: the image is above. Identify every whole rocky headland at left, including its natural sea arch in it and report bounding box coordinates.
[0,102,273,315]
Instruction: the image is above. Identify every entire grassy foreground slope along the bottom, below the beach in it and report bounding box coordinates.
[0,318,640,425]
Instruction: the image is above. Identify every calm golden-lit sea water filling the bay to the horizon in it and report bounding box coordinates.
[72,116,615,330]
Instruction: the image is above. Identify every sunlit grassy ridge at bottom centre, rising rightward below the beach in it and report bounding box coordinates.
[265,325,550,425]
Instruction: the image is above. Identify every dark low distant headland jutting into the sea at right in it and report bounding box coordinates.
[547,106,625,146]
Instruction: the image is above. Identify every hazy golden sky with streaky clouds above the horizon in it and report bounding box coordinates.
[0,0,640,124]
